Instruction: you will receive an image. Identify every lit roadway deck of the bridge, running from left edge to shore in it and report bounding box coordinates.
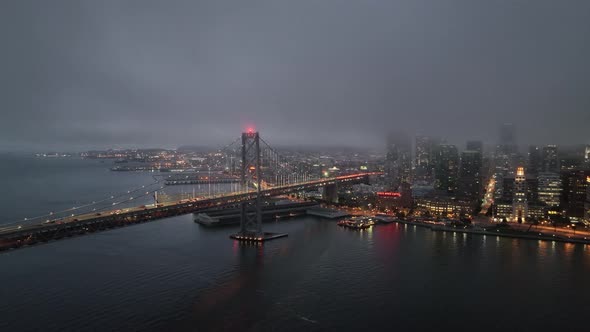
[0,172,381,251]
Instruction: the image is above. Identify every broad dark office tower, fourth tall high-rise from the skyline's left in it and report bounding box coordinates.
[457,150,482,201]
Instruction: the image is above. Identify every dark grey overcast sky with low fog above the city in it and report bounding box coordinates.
[0,0,590,149]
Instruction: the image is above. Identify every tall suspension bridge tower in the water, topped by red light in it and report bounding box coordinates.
[240,131,262,237]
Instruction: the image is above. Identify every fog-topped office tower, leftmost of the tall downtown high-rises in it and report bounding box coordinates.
[385,134,412,190]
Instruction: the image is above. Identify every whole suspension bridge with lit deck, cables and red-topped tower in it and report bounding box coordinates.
[0,130,381,250]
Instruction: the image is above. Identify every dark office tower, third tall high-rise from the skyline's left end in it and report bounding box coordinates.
[434,144,459,193]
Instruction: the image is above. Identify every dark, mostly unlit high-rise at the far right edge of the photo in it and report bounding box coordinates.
[561,170,590,221]
